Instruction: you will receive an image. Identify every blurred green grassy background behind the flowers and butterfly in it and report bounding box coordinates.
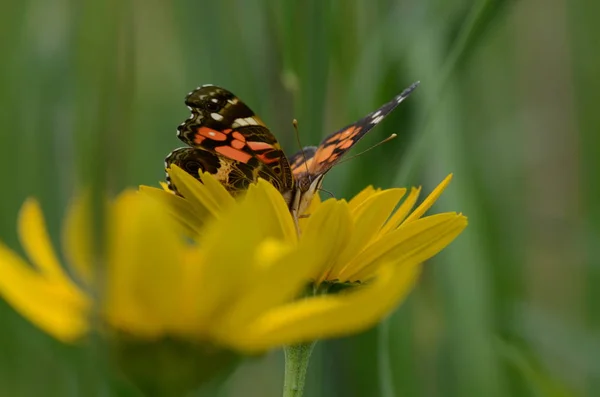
[0,0,600,397]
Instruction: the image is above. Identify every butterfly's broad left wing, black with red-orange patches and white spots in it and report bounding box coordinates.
[170,85,294,198]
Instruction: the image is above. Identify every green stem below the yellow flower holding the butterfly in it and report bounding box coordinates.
[283,342,317,397]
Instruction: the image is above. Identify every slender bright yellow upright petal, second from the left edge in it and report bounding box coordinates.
[18,199,79,294]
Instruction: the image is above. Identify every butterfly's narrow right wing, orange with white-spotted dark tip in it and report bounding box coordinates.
[308,82,419,179]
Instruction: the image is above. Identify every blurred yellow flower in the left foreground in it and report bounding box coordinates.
[0,183,292,352]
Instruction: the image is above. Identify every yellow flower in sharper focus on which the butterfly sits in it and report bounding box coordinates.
[141,166,467,349]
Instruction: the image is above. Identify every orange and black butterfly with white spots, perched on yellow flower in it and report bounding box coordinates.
[165,82,419,220]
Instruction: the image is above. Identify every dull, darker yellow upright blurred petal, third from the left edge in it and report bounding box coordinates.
[62,194,94,285]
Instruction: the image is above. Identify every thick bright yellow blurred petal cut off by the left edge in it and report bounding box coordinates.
[0,244,90,342]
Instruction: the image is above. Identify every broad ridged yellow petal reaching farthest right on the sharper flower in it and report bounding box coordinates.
[343,212,467,281]
